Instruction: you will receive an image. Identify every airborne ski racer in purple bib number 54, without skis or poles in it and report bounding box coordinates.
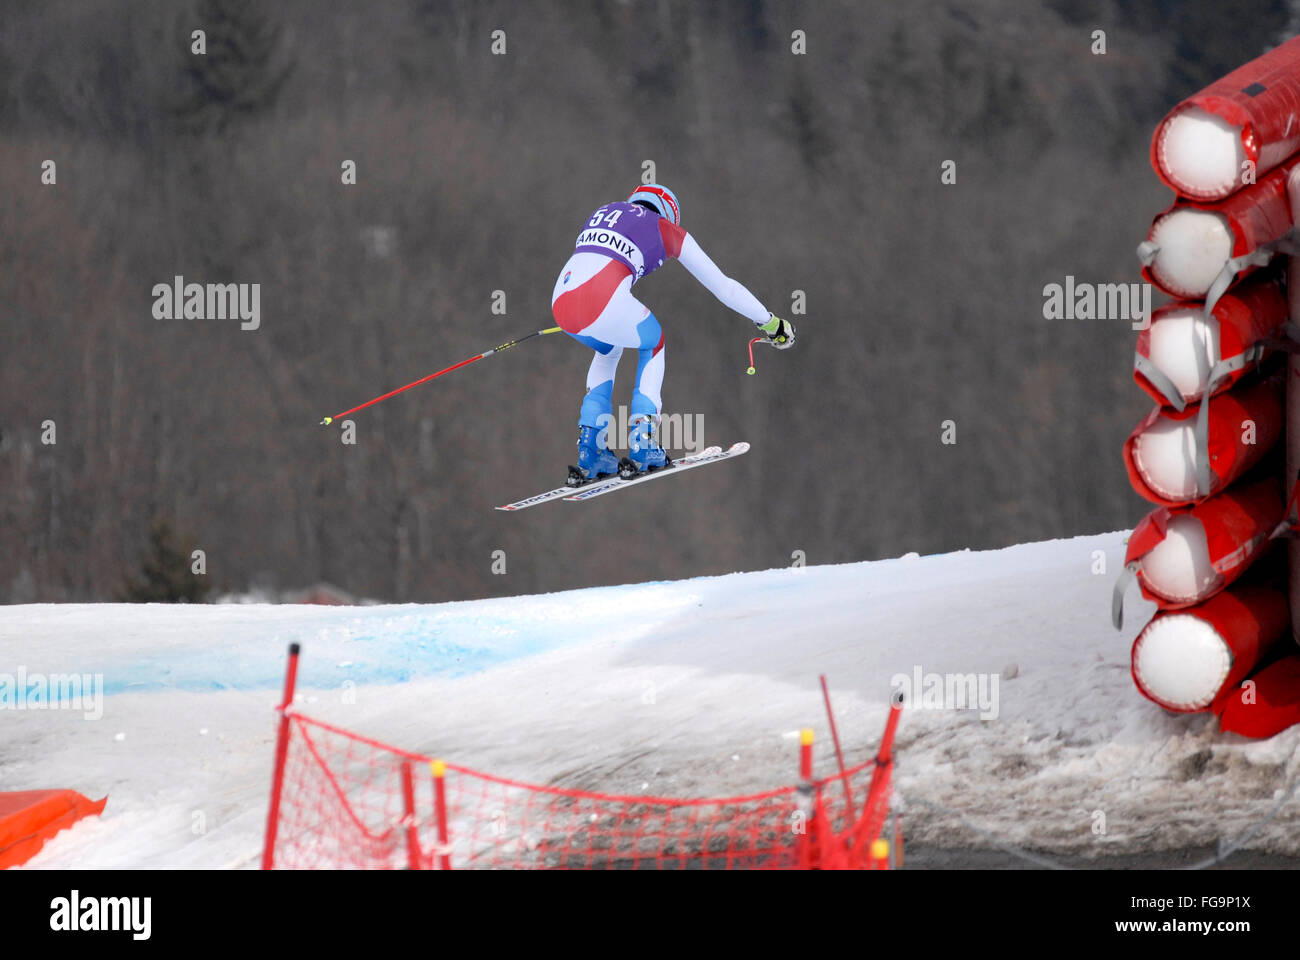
[551,183,794,485]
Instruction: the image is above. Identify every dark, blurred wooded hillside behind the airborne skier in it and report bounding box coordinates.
[0,0,1296,602]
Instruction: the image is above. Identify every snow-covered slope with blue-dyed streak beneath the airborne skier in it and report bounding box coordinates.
[0,532,1300,868]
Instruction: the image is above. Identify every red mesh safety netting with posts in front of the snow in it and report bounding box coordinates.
[263,671,898,869]
